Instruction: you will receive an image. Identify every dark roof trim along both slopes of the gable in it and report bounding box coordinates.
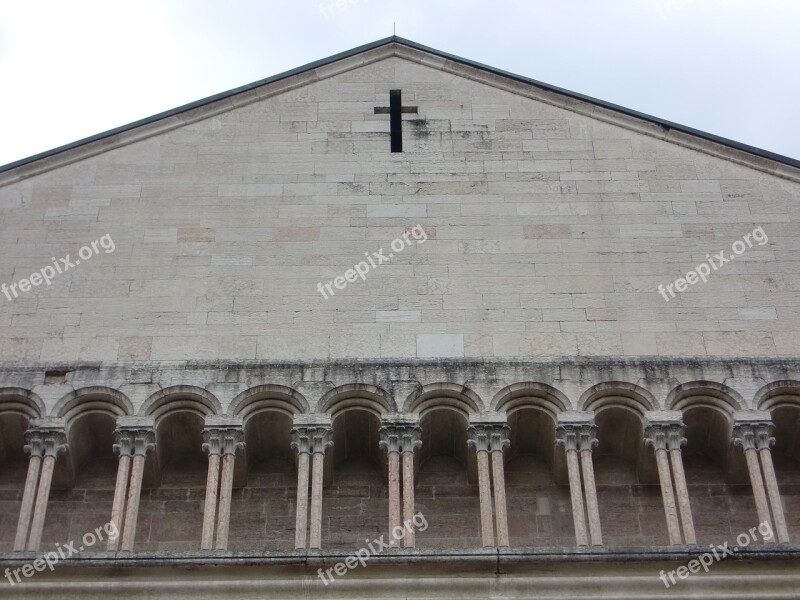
[0,36,800,173]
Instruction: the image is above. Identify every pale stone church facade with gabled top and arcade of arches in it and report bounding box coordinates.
[0,37,800,599]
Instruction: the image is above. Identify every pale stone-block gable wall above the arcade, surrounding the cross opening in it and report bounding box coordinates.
[0,50,800,362]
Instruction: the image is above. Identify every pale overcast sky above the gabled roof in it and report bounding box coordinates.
[0,0,800,164]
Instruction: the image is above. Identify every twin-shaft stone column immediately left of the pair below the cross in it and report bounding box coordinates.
[292,424,333,550]
